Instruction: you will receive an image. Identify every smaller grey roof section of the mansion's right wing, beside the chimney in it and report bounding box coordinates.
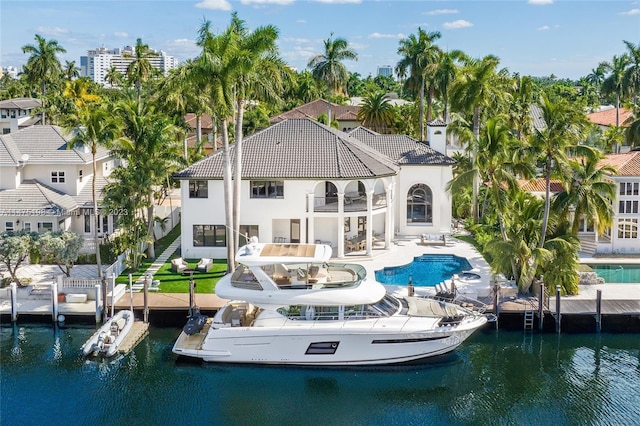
[348,127,455,166]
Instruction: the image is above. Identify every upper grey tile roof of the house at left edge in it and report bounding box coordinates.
[0,125,109,165]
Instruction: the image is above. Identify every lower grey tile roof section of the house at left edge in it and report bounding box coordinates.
[0,179,77,216]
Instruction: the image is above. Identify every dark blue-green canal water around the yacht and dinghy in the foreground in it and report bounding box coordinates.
[0,325,640,426]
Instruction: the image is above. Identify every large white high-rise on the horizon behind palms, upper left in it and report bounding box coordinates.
[80,46,178,87]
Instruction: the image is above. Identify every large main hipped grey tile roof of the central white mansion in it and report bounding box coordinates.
[174,119,398,179]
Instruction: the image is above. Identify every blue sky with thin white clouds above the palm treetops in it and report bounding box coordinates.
[0,0,640,79]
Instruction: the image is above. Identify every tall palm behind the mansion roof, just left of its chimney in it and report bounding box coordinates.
[396,27,441,141]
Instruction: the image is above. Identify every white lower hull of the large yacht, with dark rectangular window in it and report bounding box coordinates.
[173,316,486,366]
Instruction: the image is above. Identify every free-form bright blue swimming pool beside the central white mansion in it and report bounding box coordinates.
[376,254,471,287]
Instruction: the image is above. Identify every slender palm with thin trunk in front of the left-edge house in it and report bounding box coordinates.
[66,103,120,314]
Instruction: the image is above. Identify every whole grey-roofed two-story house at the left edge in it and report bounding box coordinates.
[0,125,116,251]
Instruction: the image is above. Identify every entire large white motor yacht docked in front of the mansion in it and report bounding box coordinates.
[173,237,487,366]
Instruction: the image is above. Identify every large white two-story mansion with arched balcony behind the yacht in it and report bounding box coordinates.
[175,118,454,258]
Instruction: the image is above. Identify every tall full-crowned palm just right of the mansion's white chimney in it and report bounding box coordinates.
[451,55,510,223]
